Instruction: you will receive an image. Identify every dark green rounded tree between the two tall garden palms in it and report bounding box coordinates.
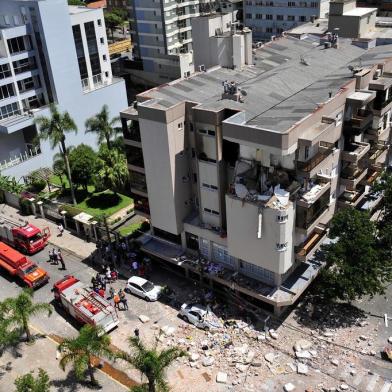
[69,144,97,190]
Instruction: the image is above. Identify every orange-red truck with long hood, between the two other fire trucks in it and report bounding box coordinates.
[0,242,49,288]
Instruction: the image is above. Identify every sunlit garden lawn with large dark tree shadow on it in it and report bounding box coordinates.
[51,176,133,217]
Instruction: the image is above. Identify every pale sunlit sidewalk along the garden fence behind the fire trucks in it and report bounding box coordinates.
[0,204,96,259]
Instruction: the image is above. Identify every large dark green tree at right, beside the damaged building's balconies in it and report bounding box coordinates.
[320,208,391,302]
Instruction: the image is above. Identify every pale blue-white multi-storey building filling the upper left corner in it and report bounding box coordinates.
[0,0,127,179]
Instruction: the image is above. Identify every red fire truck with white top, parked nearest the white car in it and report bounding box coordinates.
[53,275,118,332]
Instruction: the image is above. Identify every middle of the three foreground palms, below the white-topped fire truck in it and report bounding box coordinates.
[59,324,113,385]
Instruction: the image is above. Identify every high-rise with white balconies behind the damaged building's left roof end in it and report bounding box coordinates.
[127,0,242,84]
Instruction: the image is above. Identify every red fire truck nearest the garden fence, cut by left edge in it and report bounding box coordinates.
[0,215,50,255]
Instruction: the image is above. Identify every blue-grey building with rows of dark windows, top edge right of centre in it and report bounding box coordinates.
[244,0,329,41]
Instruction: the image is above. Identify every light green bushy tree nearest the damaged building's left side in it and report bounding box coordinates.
[96,145,129,193]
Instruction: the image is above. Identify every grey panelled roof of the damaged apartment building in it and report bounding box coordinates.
[139,36,392,132]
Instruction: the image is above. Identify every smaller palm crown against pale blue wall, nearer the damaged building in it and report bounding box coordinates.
[85,105,121,150]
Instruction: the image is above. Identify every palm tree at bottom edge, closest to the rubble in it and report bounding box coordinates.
[117,337,187,392]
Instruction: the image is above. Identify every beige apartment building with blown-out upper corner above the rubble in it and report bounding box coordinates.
[121,20,392,313]
